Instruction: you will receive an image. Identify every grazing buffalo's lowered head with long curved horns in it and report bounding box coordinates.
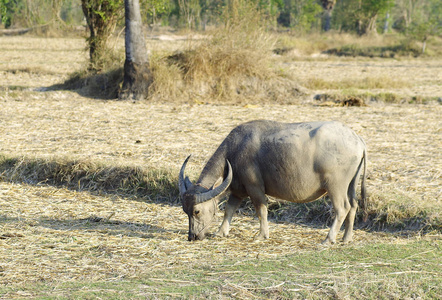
[179,155,233,241]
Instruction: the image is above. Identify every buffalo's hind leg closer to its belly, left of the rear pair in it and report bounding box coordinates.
[322,191,350,244]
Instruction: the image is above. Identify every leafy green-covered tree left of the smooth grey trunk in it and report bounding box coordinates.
[81,0,123,71]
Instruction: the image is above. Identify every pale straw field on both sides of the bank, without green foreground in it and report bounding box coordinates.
[0,37,442,284]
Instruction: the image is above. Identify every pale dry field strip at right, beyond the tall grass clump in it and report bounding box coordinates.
[286,58,442,102]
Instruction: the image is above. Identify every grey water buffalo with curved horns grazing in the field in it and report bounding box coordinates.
[179,120,367,243]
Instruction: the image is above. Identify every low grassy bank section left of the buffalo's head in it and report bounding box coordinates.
[0,155,179,205]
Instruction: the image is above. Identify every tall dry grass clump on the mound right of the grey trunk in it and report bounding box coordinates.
[150,8,284,102]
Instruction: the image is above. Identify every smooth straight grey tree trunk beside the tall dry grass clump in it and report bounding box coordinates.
[119,0,151,100]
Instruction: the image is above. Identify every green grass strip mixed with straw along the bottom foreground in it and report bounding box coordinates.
[0,240,442,299]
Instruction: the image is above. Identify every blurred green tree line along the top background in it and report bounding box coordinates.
[0,0,442,36]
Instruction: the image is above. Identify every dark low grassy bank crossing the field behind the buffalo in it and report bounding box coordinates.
[0,155,437,233]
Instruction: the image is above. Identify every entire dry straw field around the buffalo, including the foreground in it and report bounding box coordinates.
[0,37,442,299]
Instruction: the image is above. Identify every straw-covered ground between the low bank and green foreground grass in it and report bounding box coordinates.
[0,178,436,285]
